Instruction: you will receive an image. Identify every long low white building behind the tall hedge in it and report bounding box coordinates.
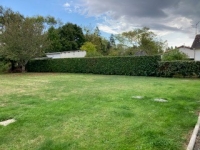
[46,50,86,59]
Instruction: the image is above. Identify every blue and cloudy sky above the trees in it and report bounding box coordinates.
[0,0,200,47]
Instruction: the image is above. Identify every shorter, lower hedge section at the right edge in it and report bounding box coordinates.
[157,61,200,77]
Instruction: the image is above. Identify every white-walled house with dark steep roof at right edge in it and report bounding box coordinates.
[191,34,200,61]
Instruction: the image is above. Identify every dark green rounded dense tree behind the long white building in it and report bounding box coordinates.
[58,23,85,51]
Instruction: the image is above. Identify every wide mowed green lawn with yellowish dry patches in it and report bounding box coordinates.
[0,73,200,150]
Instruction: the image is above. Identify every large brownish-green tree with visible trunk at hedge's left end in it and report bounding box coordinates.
[0,6,49,72]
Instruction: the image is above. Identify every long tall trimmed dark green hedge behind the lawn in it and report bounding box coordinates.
[26,56,160,76]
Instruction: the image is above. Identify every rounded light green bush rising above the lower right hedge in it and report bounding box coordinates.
[162,49,188,61]
